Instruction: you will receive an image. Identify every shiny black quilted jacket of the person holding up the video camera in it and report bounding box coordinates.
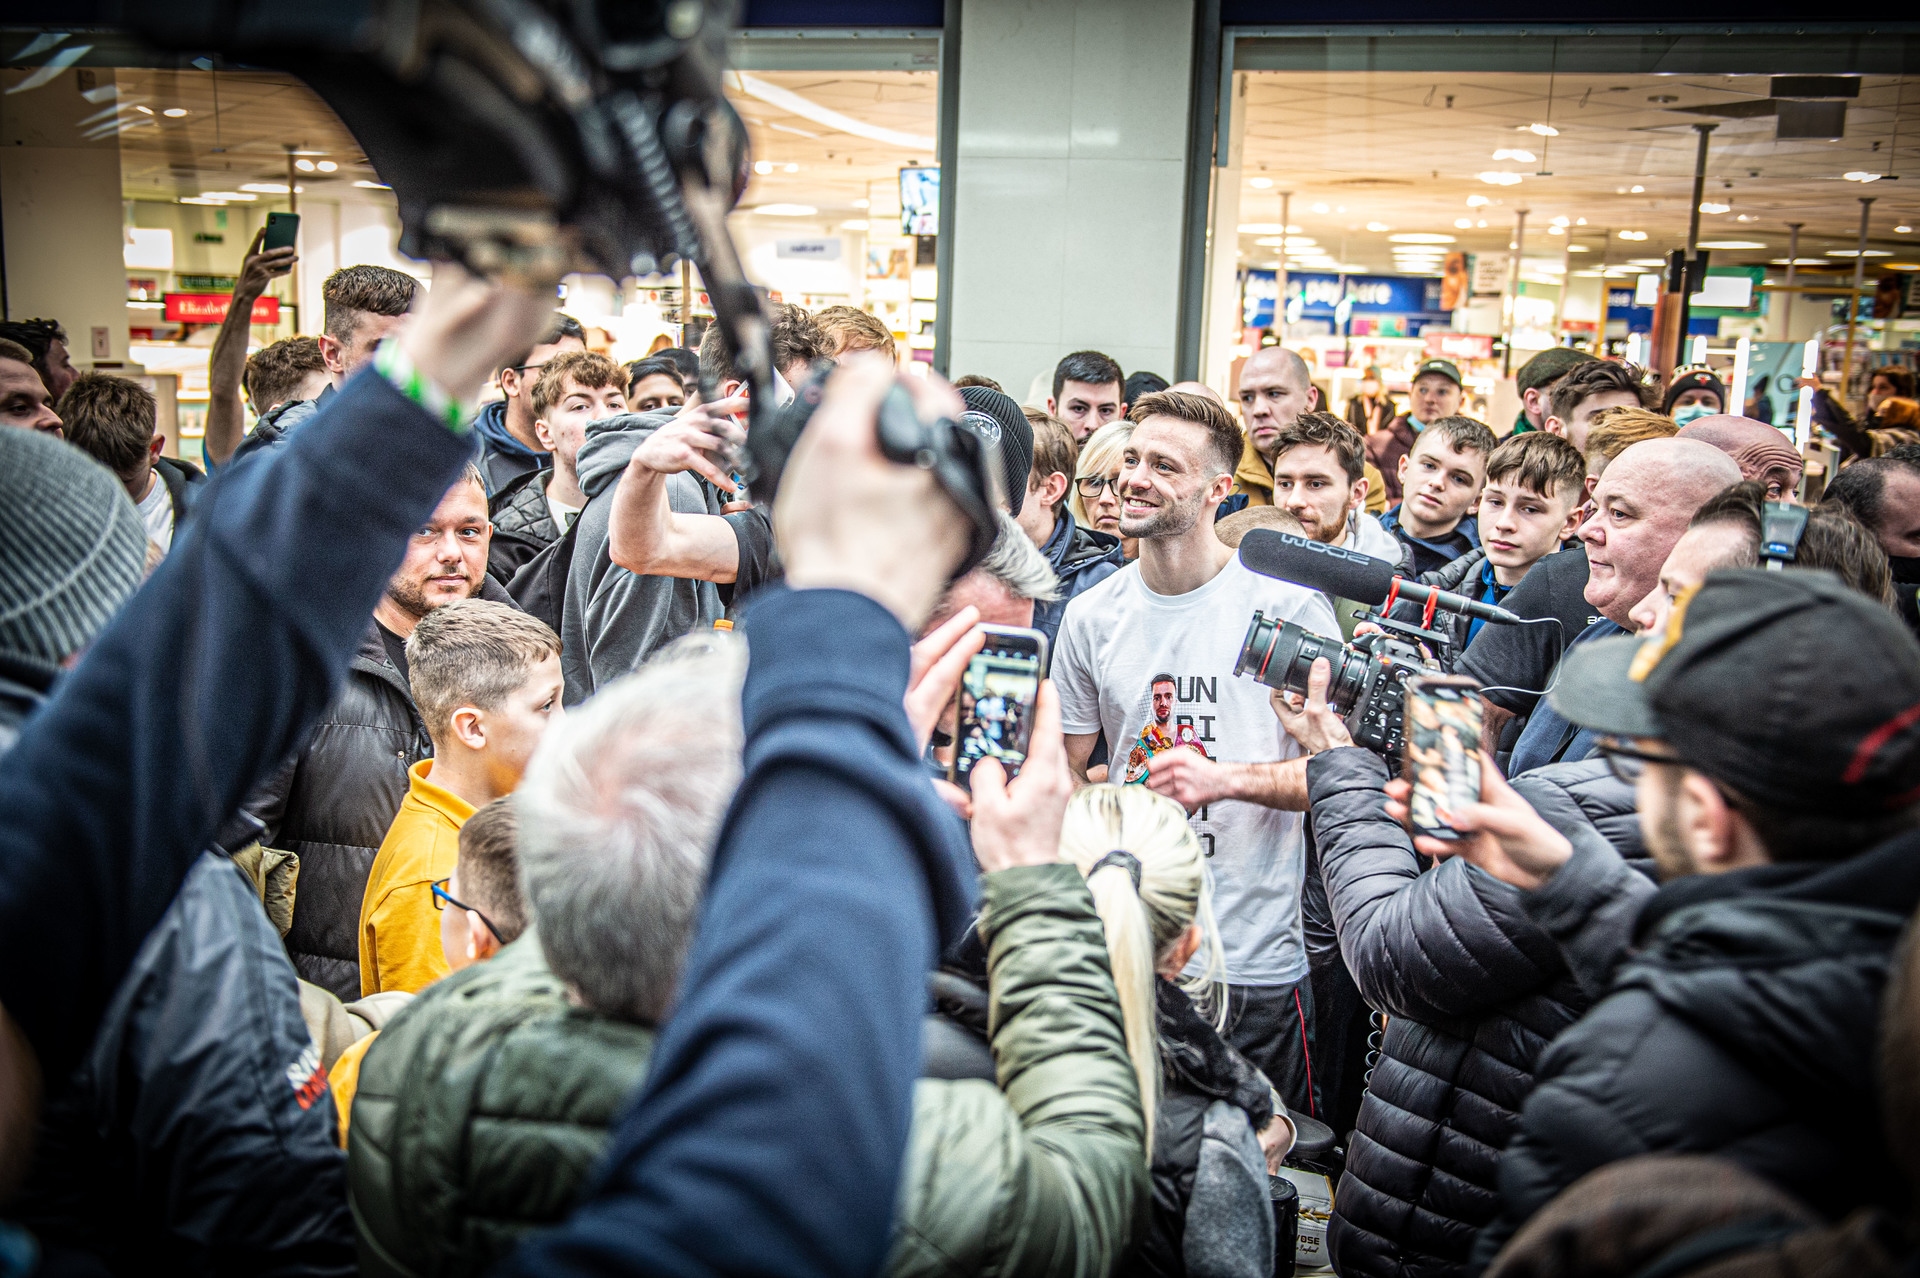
[1308,746,1632,1278]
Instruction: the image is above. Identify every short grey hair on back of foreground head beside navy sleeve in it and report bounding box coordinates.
[515,633,747,1025]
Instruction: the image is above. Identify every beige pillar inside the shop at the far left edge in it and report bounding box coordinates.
[0,69,138,368]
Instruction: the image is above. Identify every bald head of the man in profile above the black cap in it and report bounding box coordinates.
[1580,439,1740,629]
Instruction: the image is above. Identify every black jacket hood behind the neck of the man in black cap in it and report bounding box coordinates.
[1615,833,1920,1121]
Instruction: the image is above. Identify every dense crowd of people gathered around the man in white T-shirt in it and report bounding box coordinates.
[0,229,1920,1278]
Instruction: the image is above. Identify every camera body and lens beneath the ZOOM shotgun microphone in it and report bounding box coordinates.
[1233,612,1446,762]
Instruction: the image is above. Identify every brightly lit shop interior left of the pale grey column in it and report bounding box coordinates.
[39,46,939,457]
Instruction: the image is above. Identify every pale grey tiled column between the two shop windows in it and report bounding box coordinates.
[948,0,1194,401]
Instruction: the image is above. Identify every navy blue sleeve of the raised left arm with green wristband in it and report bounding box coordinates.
[0,370,472,1078]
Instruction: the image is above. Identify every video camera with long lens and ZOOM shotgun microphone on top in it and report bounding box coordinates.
[1233,528,1521,760]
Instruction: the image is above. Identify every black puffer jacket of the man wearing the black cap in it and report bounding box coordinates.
[1475,833,1920,1266]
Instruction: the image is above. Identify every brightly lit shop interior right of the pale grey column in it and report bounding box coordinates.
[1208,42,1920,426]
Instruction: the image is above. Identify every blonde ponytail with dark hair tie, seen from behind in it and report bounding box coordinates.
[1060,785,1225,1157]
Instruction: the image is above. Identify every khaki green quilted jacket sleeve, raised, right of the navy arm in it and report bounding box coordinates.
[887,865,1148,1278]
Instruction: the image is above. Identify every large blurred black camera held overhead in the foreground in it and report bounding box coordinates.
[123,0,998,570]
